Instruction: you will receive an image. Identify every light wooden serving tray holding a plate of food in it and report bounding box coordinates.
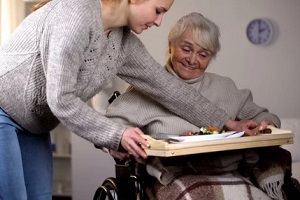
[144,126,294,157]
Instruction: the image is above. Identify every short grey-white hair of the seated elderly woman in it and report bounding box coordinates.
[168,12,221,56]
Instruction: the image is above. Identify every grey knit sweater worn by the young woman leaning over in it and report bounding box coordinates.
[0,0,229,150]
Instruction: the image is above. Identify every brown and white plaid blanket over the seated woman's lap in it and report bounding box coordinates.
[146,147,291,200]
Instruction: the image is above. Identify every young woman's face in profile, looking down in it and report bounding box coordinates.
[128,0,174,34]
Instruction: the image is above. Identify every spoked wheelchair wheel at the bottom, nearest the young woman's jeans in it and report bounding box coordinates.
[93,178,119,200]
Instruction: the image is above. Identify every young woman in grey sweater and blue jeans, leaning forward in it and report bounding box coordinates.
[0,0,255,200]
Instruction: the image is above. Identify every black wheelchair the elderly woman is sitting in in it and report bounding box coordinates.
[93,92,300,200]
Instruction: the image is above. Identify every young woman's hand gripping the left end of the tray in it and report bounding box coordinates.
[121,128,150,159]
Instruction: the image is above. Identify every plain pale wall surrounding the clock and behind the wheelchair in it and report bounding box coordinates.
[73,0,300,200]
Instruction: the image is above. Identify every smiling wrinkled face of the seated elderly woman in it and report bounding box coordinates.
[169,27,213,80]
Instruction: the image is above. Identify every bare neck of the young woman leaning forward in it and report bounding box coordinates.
[100,0,128,35]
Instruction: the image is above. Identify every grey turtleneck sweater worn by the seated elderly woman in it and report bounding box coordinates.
[106,62,280,135]
